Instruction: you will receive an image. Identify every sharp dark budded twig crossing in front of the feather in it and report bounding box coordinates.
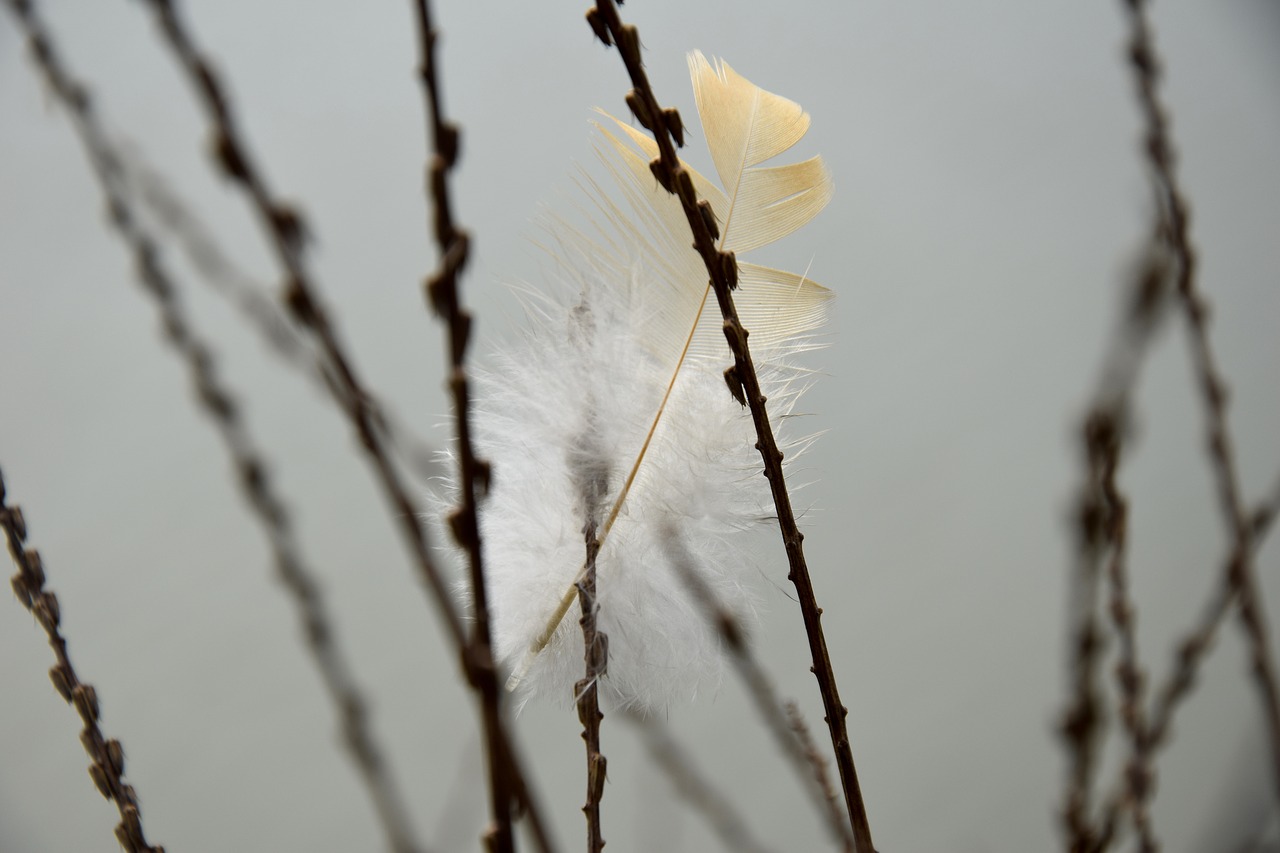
[586,0,874,853]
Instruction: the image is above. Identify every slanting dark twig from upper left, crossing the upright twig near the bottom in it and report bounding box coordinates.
[135,0,550,850]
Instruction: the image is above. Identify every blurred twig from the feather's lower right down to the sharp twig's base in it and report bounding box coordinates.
[664,528,854,850]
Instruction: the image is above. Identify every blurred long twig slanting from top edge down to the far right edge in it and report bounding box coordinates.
[1124,0,1280,802]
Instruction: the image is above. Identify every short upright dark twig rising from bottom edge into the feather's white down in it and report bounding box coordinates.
[573,523,609,853]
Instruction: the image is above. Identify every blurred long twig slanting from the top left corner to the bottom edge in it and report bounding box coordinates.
[1,9,422,853]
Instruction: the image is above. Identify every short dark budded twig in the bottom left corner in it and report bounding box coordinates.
[0,468,164,853]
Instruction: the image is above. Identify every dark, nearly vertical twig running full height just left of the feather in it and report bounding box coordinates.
[413,0,521,853]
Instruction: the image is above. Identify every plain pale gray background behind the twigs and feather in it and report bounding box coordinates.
[0,0,1280,853]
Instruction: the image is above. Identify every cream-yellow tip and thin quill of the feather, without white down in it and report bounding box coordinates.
[507,51,832,689]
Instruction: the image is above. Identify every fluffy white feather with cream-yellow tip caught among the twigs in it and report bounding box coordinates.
[465,53,832,708]
